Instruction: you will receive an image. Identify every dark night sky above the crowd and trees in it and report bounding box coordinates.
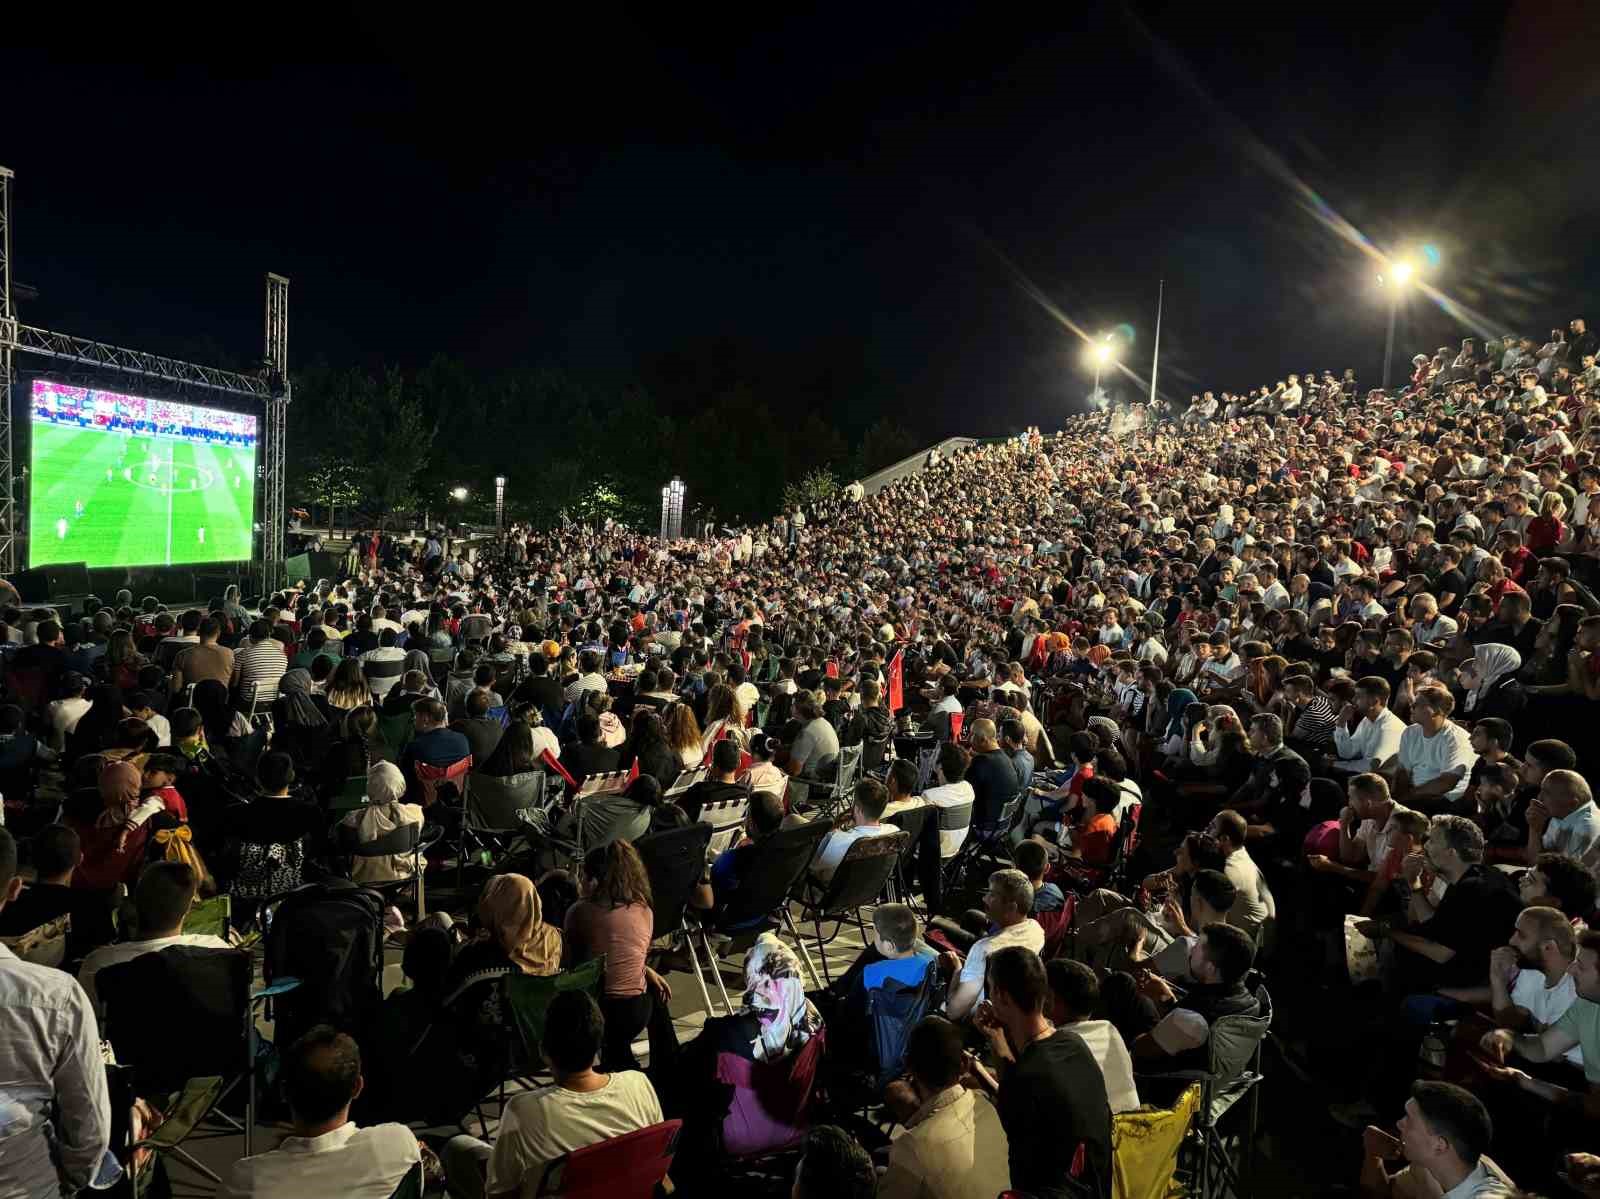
[0,2,1600,434]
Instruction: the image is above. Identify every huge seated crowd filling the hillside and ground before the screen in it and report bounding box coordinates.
[0,320,1600,1199]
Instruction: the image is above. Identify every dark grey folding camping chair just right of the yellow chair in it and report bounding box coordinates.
[1136,981,1272,1199]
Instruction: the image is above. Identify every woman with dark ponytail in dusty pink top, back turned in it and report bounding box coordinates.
[562,840,672,1069]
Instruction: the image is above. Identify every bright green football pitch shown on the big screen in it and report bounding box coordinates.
[29,418,256,567]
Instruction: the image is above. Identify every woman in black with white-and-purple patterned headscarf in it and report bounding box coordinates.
[674,933,822,1178]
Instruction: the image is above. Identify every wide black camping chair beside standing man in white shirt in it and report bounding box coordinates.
[94,944,299,1156]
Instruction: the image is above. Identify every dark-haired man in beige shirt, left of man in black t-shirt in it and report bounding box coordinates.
[876,1018,1011,1199]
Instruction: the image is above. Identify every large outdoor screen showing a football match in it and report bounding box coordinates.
[27,379,256,567]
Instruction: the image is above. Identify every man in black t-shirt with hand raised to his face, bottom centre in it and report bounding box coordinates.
[973,944,1112,1199]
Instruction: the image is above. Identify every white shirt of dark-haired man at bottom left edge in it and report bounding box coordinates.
[218,1124,421,1199]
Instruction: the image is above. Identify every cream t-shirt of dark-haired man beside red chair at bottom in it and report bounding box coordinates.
[485,1069,661,1194]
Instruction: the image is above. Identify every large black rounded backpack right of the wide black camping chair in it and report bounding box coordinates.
[261,879,384,1045]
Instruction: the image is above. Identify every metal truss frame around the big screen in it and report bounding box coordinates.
[0,166,290,591]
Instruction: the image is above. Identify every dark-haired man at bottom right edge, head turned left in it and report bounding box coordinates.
[1362,1082,1515,1199]
